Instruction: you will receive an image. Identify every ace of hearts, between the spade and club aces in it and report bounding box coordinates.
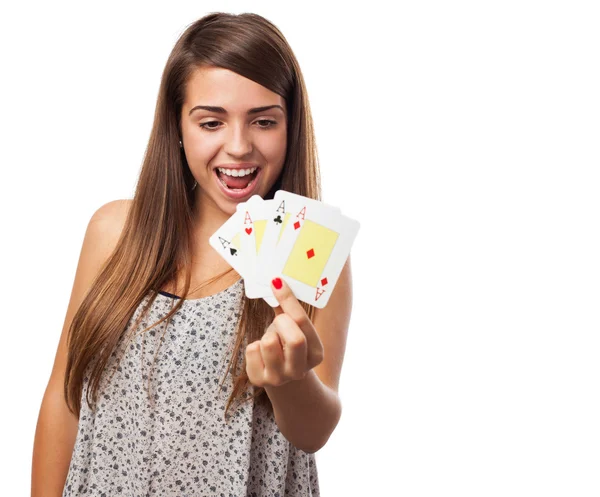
[237,195,279,307]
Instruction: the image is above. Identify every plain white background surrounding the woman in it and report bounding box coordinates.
[0,0,600,497]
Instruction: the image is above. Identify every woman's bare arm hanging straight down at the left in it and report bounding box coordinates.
[31,200,129,497]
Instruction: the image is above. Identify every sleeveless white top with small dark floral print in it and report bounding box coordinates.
[62,279,320,497]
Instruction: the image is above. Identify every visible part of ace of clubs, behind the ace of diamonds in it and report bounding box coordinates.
[256,190,340,286]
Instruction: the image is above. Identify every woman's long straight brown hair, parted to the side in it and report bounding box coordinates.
[64,12,321,417]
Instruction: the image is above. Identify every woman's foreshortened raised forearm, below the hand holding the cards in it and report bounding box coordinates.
[265,369,342,453]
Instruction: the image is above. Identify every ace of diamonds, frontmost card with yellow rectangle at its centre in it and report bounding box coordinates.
[259,191,360,308]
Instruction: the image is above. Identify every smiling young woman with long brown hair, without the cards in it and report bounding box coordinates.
[32,13,352,497]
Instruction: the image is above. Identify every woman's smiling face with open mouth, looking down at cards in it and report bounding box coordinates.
[181,67,287,215]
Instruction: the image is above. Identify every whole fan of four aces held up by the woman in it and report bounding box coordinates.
[209,190,359,308]
